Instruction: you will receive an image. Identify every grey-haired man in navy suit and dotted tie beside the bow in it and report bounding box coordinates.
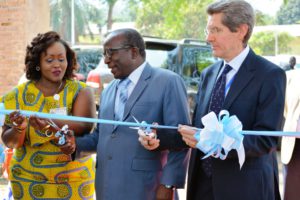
[179,0,286,200]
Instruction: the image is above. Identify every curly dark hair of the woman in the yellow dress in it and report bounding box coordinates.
[25,31,76,81]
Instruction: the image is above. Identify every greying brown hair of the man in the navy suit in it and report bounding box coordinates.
[206,0,255,44]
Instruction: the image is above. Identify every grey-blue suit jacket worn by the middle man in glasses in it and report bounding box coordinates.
[76,64,189,200]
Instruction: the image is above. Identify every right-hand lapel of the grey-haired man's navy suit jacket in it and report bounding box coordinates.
[223,50,256,110]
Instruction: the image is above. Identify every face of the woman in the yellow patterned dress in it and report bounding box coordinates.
[40,42,68,82]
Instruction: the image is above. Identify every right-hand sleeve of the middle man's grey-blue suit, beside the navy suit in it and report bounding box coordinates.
[158,76,190,188]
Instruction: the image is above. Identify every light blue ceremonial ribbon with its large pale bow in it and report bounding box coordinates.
[0,103,300,167]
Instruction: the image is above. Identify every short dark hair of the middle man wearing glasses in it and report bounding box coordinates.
[111,28,146,59]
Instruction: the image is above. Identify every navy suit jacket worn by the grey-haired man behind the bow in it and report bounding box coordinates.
[187,50,286,200]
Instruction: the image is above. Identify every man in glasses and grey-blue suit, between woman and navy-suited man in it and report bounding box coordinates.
[61,29,189,200]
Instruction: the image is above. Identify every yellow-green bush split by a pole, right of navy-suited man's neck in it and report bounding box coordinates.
[249,31,295,56]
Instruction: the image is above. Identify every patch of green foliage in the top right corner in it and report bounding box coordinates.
[277,0,300,24]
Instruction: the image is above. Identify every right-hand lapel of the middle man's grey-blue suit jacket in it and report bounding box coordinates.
[123,64,151,121]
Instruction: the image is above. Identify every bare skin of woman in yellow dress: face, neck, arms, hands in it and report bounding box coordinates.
[2,42,96,148]
